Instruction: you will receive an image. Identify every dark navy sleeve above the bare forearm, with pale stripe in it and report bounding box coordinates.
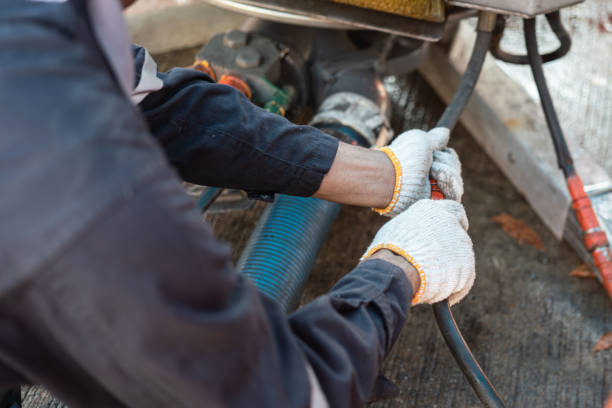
[133,46,338,196]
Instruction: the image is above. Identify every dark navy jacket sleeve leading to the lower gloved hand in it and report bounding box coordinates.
[289,260,412,407]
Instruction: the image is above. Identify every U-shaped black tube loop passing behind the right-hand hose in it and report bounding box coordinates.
[491,10,572,65]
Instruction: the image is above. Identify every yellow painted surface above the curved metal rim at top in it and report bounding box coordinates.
[331,0,445,22]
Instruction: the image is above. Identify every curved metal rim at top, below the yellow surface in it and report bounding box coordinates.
[205,0,445,41]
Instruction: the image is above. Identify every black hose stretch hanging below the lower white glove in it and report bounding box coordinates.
[434,300,505,407]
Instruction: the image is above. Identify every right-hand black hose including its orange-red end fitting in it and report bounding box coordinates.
[524,18,612,300]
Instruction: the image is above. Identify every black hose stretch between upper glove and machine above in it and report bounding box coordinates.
[438,31,491,129]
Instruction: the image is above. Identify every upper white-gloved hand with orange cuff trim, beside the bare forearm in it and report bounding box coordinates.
[374,127,463,217]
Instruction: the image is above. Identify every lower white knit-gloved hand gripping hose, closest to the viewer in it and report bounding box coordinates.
[362,200,476,305]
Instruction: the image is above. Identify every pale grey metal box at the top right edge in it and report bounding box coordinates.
[447,0,584,17]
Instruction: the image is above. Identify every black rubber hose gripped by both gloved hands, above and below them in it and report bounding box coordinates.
[433,27,505,408]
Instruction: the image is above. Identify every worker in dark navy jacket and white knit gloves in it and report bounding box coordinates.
[0,0,474,408]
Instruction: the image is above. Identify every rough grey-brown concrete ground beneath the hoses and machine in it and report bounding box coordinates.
[24,1,612,408]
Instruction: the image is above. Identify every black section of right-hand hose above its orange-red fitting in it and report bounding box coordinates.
[523,18,576,178]
